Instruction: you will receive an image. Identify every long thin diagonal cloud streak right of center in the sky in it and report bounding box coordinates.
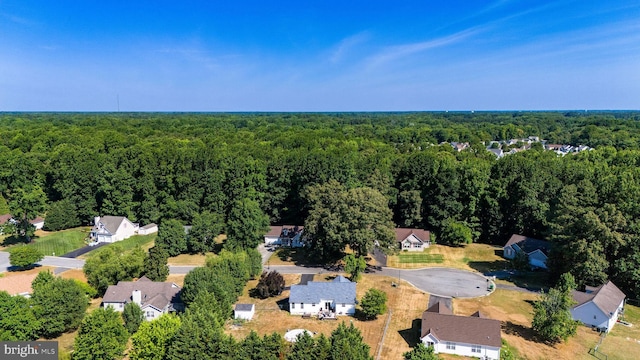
[367,27,485,68]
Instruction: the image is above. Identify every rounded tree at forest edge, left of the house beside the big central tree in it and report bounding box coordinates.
[224,198,269,250]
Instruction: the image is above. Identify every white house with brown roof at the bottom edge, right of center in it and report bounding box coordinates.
[420,303,502,360]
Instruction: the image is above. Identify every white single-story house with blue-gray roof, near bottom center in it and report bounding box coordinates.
[289,275,356,317]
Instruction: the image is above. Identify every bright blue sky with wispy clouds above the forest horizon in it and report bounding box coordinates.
[0,0,640,111]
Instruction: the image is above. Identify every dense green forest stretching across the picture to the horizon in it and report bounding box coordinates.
[0,112,640,297]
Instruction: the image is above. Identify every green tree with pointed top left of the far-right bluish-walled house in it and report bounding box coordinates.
[532,273,578,344]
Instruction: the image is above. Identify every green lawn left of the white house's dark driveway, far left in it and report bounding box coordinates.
[6,227,89,256]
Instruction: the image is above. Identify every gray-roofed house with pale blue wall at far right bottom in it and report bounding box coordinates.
[571,281,626,331]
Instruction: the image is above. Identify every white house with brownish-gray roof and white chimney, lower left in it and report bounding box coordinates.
[102,276,184,320]
